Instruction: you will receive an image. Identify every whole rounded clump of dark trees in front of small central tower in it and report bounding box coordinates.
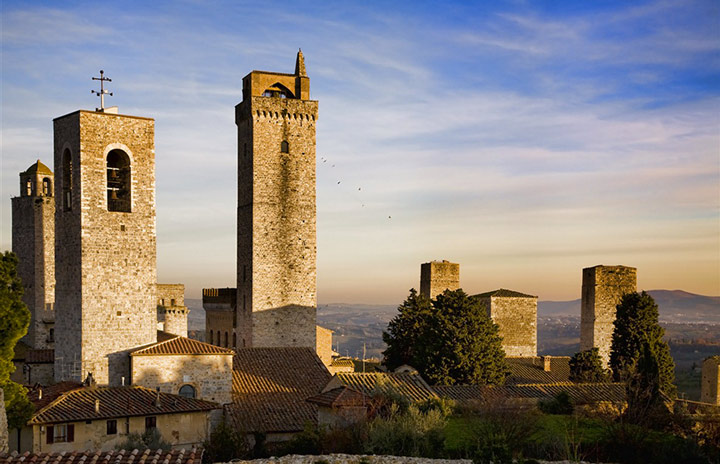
[383,290,509,385]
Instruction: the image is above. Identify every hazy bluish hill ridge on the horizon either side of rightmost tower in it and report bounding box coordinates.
[538,290,720,324]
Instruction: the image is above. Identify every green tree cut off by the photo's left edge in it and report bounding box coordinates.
[0,251,32,428]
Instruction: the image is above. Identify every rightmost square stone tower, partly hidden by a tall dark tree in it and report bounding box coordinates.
[580,265,637,366]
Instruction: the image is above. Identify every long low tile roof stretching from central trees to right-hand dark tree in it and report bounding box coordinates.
[433,382,625,404]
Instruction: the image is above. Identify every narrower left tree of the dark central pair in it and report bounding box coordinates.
[383,288,432,370]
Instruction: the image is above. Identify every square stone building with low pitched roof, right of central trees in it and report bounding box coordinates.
[475,288,537,356]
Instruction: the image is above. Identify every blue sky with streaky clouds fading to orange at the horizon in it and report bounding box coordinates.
[0,0,720,304]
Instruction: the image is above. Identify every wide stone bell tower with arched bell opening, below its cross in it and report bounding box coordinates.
[53,110,157,385]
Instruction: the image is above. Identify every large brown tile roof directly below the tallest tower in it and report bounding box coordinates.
[225,348,330,433]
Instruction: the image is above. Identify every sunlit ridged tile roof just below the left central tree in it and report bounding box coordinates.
[323,372,437,401]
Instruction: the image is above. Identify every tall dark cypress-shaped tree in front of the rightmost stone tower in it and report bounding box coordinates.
[610,292,676,421]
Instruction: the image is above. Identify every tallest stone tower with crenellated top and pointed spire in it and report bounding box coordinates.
[232,52,318,349]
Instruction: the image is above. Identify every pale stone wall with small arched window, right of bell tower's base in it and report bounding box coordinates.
[132,354,232,404]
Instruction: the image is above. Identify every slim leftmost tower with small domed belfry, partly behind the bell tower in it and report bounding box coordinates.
[12,160,55,349]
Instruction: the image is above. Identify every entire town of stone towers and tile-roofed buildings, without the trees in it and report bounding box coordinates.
[0,51,720,463]
